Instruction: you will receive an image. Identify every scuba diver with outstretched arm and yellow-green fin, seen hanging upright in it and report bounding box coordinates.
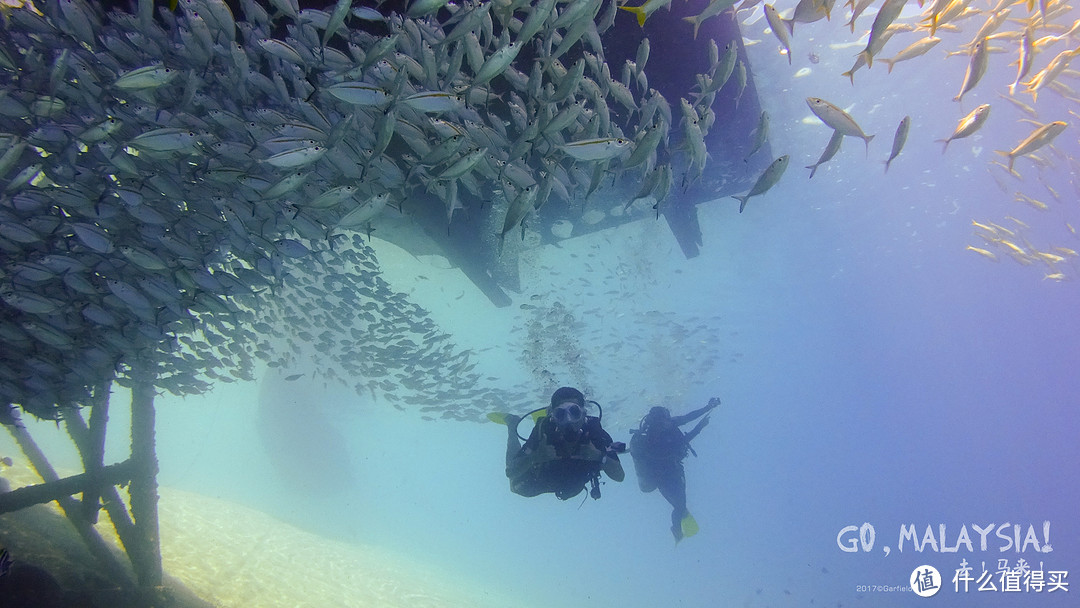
[630,397,720,542]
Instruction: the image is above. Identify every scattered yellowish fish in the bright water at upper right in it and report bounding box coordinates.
[735,0,1080,281]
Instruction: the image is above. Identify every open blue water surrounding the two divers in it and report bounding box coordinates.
[2,2,1080,608]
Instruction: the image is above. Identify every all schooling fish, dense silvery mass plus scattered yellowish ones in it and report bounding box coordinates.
[0,0,1080,419]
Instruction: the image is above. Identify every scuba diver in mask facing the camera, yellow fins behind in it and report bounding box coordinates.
[488,387,626,500]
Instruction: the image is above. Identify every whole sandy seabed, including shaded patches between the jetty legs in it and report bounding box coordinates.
[0,463,518,608]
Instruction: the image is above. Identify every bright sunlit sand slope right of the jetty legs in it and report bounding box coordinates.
[159,488,522,608]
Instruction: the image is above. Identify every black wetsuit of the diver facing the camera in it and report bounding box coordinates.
[508,416,617,500]
